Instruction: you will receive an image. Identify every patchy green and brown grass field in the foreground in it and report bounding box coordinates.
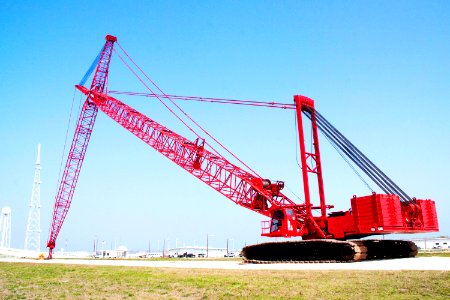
[0,263,450,299]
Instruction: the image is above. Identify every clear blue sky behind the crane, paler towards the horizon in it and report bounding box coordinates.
[0,1,450,250]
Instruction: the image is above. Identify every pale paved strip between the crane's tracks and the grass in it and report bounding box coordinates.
[0,257,450,271]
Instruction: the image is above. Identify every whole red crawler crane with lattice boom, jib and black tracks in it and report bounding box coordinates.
[47,35,438,260]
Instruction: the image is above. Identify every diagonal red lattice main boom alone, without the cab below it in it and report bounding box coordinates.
[77,86,300,216]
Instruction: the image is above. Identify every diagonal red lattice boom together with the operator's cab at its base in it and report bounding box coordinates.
[77,86,334,238]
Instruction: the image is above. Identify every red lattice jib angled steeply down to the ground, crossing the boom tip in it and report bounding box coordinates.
[47,35,117,258]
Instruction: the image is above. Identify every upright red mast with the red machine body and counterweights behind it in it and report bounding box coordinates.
[294,95,439,239]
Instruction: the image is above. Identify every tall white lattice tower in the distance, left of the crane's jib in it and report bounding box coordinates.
[24,144,41,252]
